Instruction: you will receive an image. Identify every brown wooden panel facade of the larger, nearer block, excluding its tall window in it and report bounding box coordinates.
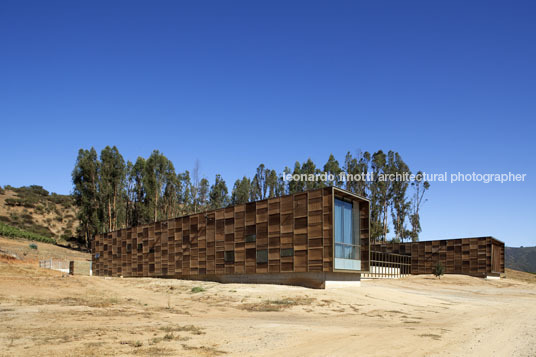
[92,187,370,279]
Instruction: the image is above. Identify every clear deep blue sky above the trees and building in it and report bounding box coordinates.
[0,0,536,246]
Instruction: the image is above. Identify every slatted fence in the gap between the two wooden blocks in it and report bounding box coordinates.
[362,251,411,279]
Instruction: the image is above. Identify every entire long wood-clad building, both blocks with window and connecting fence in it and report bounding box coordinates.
[92,187,504,288]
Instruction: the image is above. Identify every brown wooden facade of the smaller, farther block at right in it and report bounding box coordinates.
[371,237,504,277]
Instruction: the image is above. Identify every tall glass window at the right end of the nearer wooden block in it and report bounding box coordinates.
[335,199,360,260]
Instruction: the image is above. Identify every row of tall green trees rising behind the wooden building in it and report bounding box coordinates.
[72,146,430,244]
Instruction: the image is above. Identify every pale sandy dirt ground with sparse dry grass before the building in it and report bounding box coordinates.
[0,241,536,356]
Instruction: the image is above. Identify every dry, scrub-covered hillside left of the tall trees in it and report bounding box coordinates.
[0,185,78,242]
